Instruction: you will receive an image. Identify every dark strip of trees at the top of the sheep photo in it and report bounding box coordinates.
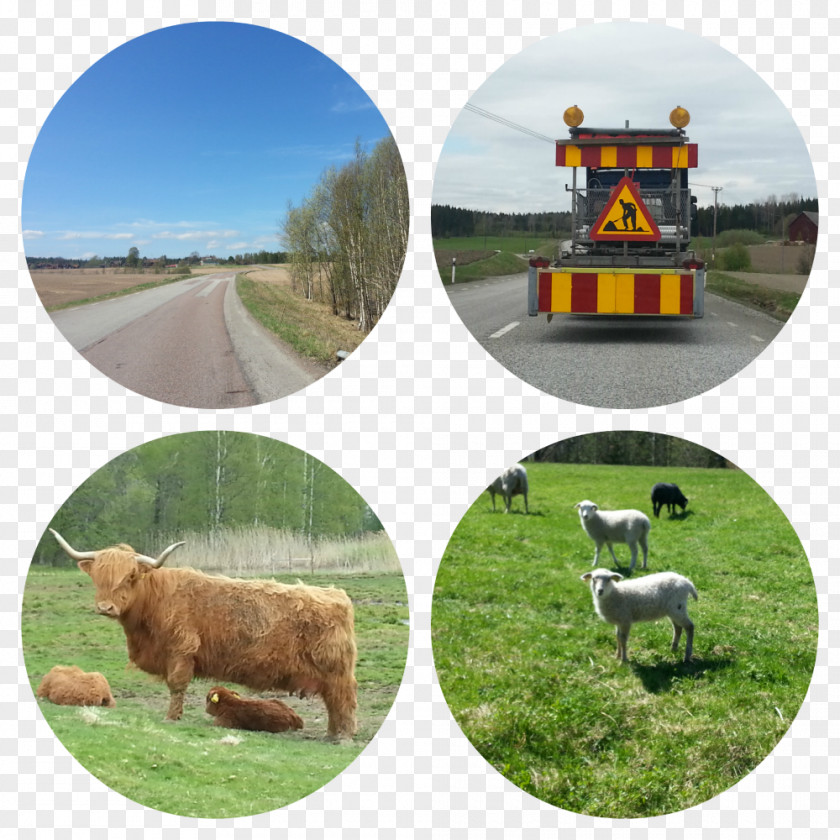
[530,431,734,469]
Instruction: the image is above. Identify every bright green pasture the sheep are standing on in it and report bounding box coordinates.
[432,463,819,818]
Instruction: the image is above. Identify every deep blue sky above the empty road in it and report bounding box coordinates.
[22,22,389,258]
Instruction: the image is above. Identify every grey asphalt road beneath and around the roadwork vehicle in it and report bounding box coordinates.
[444,274,784,408]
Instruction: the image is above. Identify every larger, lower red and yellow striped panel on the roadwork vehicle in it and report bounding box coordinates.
[537,268,694,315]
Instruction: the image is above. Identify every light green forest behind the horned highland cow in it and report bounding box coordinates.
[34,431,382,564]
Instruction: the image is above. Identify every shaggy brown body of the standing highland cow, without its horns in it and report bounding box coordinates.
[66,545,356,737]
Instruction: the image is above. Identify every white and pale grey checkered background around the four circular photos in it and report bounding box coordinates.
[0,0,840,840]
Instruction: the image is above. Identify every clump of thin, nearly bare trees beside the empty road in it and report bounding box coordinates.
[281,136,410,332]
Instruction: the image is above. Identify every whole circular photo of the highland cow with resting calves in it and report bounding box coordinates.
[21,431,409,819]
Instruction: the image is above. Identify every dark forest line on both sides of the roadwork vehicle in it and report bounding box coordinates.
[432,195,819,239]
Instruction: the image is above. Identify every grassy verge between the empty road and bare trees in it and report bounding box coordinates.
[236,274,365,367]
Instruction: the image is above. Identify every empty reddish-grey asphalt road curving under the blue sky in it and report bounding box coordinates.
[52,273,325,408]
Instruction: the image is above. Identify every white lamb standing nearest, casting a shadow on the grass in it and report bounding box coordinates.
[580,569,697,662]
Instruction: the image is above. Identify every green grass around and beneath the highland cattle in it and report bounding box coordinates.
[22,567,409,818]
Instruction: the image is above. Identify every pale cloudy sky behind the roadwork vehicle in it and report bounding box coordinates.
[433,22,817,213]
